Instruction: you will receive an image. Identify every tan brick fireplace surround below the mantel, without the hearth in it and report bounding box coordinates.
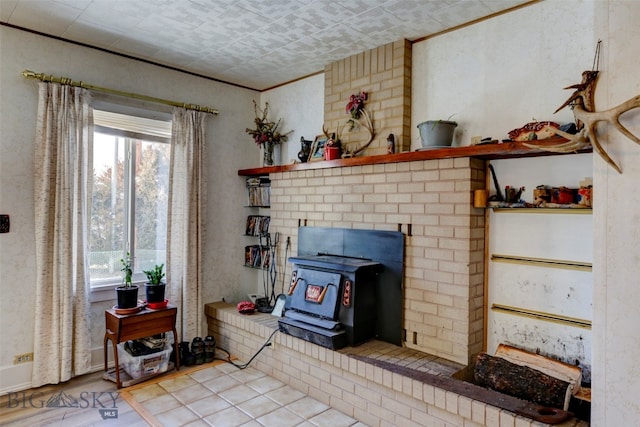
[270,157,485,365]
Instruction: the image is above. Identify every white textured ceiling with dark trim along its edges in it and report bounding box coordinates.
[0,0,529,90]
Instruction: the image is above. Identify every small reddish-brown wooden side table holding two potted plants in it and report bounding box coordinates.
[104,304,180,388]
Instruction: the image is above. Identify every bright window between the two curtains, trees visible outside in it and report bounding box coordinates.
[89,110,171,289]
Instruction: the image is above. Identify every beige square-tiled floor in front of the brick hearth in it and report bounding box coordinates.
[130,363,365,427]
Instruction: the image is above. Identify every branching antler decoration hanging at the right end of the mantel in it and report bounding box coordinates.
[524,70,640,173]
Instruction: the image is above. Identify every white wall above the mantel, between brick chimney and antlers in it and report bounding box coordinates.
[411,0,595,148]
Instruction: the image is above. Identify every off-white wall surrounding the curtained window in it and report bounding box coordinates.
[0,27,259,392]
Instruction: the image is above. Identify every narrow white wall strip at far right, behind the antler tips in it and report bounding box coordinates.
[592,0,640,426]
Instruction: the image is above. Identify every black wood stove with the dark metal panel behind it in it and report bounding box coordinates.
[278,227,404,349]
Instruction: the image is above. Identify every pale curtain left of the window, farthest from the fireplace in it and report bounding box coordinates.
[31,83,93,387]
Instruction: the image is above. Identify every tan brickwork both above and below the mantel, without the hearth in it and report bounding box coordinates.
[302,40,485,364]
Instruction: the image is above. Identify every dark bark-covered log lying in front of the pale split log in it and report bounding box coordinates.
[474,353,571,410]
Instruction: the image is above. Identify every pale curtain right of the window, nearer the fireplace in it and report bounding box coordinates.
[167,108,208,341]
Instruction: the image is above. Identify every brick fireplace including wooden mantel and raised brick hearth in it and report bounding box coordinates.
[225,147,588,427]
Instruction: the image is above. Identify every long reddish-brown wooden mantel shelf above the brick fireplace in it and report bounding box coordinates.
[238,138,592,176]
